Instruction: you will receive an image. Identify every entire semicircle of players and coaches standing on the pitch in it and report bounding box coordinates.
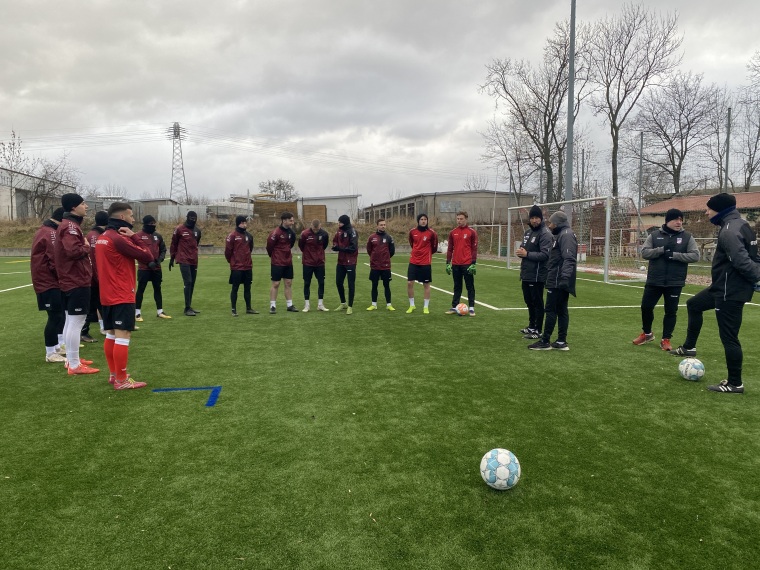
[31,194,760,393]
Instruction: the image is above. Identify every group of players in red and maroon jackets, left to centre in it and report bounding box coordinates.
[31,197,478,390]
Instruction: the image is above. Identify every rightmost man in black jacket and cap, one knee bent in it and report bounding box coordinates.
[671,194,760,394]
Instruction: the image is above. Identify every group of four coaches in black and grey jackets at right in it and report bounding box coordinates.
[516,193,760,394]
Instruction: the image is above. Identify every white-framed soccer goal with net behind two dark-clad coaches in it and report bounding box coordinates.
[505,196,646,283]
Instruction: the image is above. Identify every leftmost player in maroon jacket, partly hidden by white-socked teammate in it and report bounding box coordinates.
[31,208,66,362]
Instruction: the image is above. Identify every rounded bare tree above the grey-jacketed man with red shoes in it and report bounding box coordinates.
[626,71,718,194]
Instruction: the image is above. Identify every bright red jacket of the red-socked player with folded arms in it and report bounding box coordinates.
[95,227,153,306]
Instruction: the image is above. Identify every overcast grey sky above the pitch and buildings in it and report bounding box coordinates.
[0,0,760,205]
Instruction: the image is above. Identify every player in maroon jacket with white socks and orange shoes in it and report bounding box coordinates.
[55,193,100,375]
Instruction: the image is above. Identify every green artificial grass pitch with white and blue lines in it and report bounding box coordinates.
[0,256,760,569]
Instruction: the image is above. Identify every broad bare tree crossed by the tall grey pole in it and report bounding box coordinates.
[480,22,588,200]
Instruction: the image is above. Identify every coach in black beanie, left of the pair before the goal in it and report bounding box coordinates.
[515,206,553,339]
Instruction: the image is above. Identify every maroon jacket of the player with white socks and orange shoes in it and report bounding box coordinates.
[55,214,92,292]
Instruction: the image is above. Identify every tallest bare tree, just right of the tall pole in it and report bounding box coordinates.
[587,4,682,197]
